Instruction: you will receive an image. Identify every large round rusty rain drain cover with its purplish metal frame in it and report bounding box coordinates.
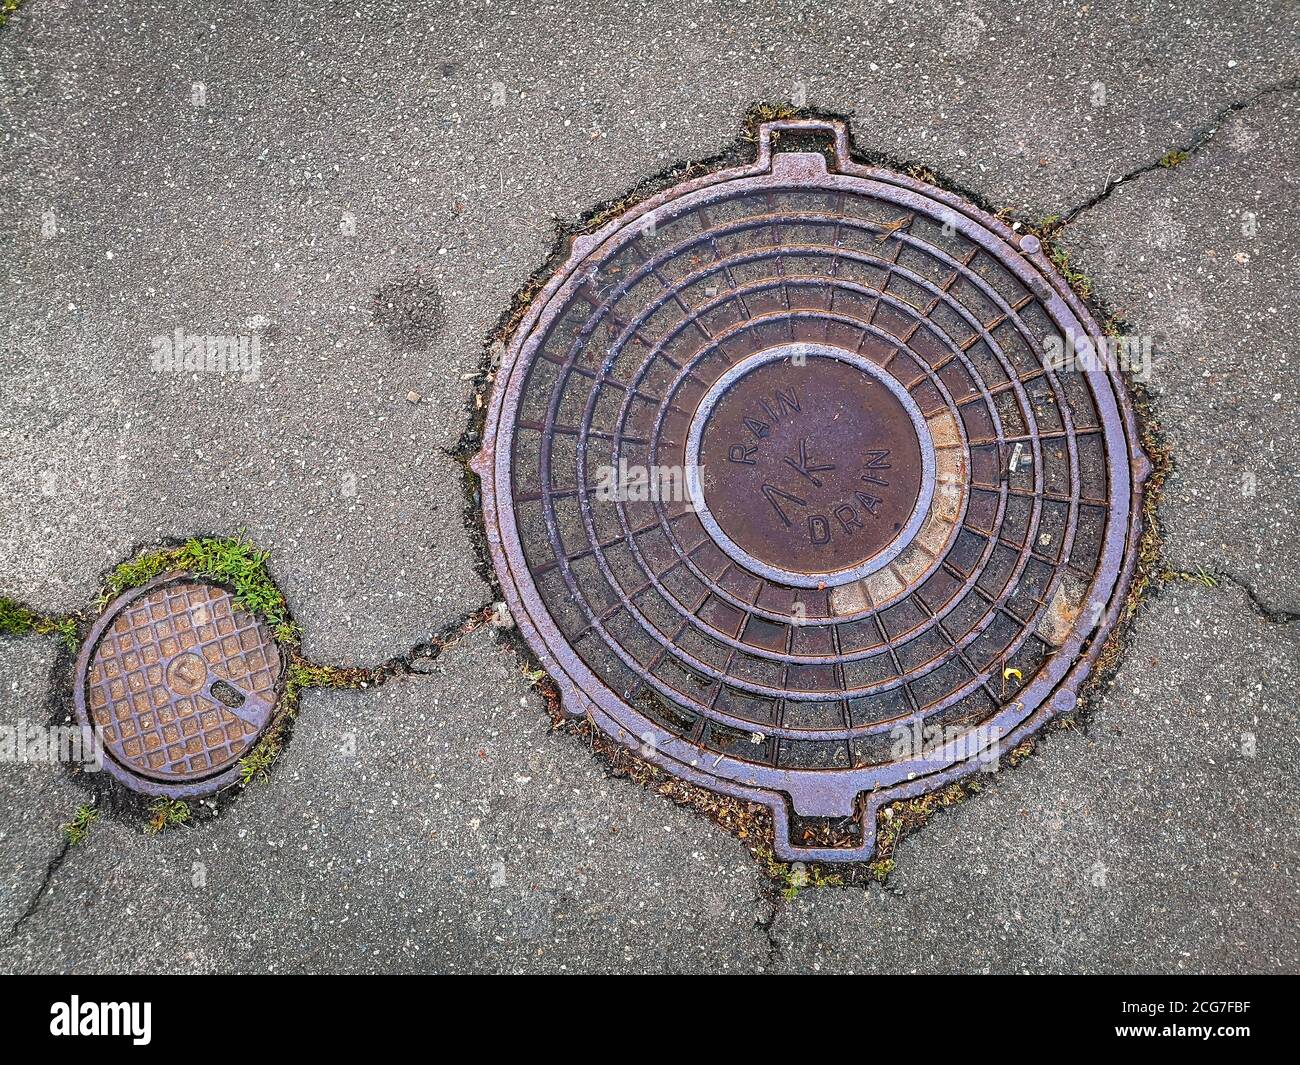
[475,121,1148,860]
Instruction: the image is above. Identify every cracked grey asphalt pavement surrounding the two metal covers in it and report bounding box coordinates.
[0,0,1300,973]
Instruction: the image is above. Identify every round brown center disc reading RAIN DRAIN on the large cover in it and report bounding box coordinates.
[686,343,935,588]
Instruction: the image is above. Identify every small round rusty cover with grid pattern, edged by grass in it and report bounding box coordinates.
[74,576,282,797]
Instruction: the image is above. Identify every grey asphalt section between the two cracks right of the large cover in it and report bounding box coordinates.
[1065,90,1300,610]
